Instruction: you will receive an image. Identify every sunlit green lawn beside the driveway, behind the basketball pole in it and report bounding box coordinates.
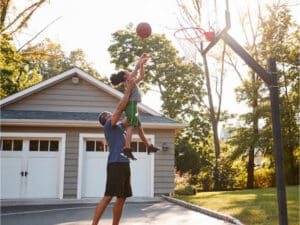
[175,186,300,225]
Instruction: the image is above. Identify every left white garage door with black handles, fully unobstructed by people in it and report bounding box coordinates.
[0,133,63,199]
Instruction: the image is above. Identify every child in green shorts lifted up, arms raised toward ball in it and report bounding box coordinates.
[110,53,160,160]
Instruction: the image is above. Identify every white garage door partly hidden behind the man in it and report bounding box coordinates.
[79,135,154,198]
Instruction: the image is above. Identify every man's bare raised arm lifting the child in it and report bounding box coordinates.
[111,80,135,126]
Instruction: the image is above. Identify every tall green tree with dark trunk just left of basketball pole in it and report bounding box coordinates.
[228,2,264,189]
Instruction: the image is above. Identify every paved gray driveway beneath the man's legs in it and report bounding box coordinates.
[1,201,233,225]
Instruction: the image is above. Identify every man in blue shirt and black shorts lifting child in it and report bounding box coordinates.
[92,80,135,225]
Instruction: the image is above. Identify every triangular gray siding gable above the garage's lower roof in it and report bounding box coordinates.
[4,78,119,112]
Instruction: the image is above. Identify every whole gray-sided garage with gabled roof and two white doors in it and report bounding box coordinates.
[0,68,185,199]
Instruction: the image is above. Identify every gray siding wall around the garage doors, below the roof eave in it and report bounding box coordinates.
[1,126,174,198]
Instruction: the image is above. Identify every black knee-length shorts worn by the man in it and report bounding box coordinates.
[105,162,132,198]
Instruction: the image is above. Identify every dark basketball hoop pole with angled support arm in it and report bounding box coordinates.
[201,0,288,225]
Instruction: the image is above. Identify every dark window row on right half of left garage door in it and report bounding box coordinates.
[29,140,59,152]
